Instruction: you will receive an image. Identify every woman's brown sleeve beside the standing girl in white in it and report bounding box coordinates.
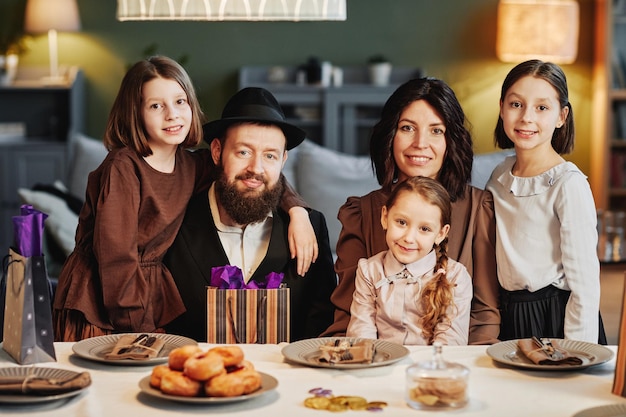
[469,189,500,345]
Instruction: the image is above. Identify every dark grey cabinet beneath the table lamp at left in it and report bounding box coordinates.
[0,69,84,252]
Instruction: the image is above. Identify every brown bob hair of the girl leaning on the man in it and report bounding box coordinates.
[104,56,204,156]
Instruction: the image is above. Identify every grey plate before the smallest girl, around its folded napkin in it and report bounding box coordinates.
[282,337,409,369]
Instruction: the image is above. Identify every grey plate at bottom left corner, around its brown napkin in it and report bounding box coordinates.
[0,366,87,404]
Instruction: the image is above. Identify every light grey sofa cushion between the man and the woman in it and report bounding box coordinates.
[294,141,380,252]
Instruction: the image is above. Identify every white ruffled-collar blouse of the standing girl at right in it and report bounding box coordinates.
[487,156,600,343]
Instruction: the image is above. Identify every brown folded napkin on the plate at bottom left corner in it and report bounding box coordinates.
[0,372,91,395]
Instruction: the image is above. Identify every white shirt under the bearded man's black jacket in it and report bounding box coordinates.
[209,183,273,283]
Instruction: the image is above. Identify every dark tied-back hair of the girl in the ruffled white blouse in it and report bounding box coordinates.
[494,59,575,155]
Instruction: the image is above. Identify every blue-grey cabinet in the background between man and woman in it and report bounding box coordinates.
[239,67,421,155]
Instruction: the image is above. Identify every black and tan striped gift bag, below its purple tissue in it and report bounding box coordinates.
[207,287,290,344]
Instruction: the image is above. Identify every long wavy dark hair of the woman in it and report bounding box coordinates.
[370,77,474,201]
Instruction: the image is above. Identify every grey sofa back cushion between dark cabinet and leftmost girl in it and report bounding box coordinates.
[68,133,108,200]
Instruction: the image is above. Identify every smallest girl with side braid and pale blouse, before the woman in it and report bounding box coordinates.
[346,177,472,345]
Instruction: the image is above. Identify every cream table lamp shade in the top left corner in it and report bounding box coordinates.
[24,0,80,33]
